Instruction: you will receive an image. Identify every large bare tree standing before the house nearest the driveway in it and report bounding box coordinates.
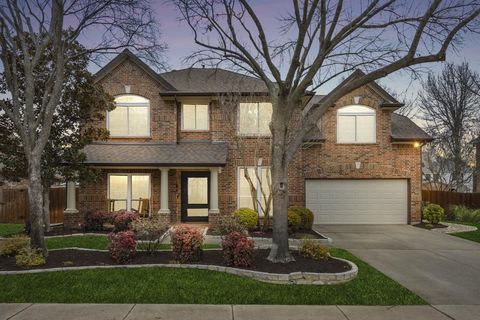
[174,0,480,262]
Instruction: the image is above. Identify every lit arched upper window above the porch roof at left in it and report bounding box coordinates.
[107,94,150,137]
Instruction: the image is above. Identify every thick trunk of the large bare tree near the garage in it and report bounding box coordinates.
[268,99,295,263]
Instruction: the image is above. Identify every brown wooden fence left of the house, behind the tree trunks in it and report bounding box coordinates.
[0,187,78,223]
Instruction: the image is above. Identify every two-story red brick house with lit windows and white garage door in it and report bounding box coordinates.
[65,51,431,227]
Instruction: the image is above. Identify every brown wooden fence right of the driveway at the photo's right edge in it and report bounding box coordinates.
[422,190,480,212]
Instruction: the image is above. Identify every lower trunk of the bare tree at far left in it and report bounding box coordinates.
[28,156,48,256]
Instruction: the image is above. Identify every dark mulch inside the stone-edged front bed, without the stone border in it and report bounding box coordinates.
[0,249,351,274]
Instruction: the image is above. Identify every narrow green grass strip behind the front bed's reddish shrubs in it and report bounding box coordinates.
[47,236,220,250]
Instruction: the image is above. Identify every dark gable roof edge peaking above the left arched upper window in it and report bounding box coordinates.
[95,49,176,91]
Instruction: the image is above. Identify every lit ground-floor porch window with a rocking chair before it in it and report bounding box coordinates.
[108,174,150,211]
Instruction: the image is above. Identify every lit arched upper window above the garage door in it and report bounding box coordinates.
[337,105,376,143]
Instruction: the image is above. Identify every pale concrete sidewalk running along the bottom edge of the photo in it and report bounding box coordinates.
[0,304,480,320]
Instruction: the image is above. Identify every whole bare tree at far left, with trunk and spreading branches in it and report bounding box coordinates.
[0,0,163,254]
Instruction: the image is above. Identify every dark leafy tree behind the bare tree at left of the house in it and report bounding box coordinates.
[0,42,114,231]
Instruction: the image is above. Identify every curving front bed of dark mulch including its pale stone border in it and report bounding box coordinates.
[0,249,358,284]
